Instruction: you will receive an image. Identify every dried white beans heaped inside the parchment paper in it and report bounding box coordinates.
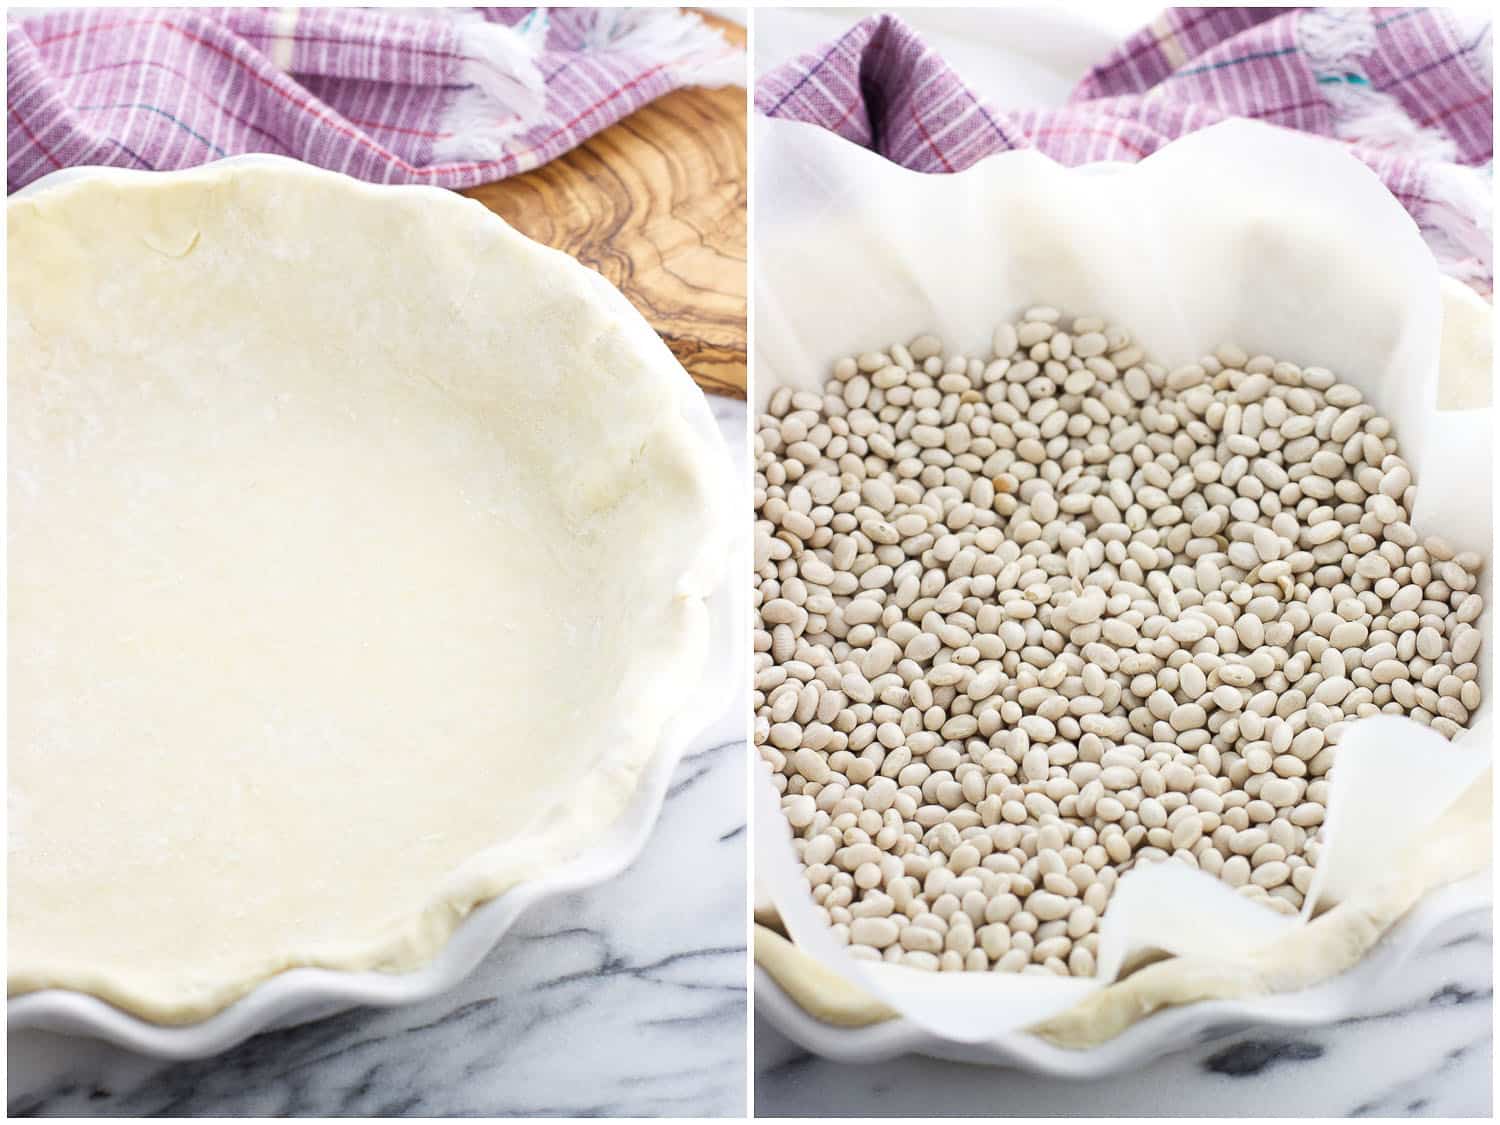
[753,308,1482,977]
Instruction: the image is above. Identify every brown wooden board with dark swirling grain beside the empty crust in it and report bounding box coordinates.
[465,15,747,398]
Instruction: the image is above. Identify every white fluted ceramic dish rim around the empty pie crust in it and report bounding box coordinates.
[8,156,747,1059]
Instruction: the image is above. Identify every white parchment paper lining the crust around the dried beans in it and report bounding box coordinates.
[755,119,1493,1043]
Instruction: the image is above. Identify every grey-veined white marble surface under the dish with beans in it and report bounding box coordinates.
[755,915,1494,1118]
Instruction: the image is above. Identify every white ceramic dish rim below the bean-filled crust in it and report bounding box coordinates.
[755,873,1493,1079]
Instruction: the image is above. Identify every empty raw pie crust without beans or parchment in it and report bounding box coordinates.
[8,162,726,1023]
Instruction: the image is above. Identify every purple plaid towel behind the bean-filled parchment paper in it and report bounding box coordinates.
[756,8,1494,294]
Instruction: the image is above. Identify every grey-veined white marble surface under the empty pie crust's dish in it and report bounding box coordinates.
[8,399,749,1118]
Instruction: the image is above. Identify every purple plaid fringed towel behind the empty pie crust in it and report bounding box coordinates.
[8,8,744,192]
